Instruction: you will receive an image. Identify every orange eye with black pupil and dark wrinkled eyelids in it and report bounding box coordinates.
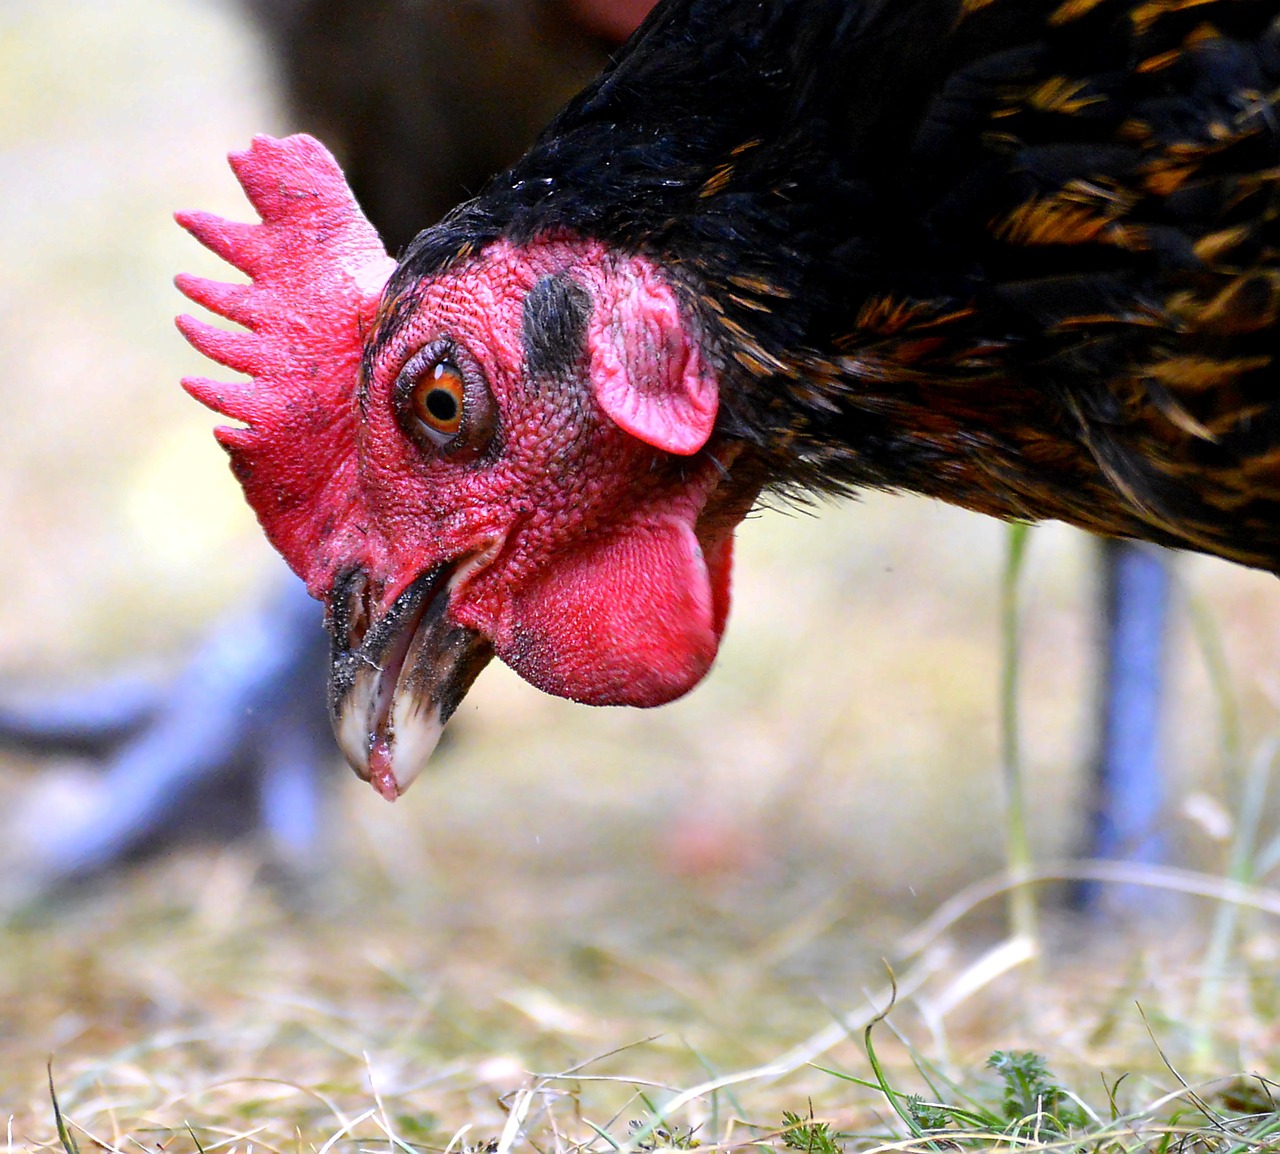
[393,338,498,459]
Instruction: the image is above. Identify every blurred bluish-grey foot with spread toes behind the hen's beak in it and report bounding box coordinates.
[0,577,337,884]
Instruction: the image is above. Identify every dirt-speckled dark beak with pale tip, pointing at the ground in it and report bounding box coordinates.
[329,564,493,801]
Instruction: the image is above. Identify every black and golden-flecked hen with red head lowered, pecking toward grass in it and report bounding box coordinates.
[179,0,1280,797]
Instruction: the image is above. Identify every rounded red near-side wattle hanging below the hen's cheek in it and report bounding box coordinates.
[497,516,731,706]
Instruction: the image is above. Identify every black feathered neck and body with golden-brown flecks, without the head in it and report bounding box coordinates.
[389,0,1280,569]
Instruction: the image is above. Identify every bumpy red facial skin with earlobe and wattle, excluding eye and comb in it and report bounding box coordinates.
[358,239,732,705]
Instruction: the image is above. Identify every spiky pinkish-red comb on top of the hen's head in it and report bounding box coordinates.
[177,136,394,592]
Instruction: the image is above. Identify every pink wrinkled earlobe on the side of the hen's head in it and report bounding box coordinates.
[589,260,719,457]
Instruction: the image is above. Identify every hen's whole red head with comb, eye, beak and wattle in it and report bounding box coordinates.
[178,137,755,797]
